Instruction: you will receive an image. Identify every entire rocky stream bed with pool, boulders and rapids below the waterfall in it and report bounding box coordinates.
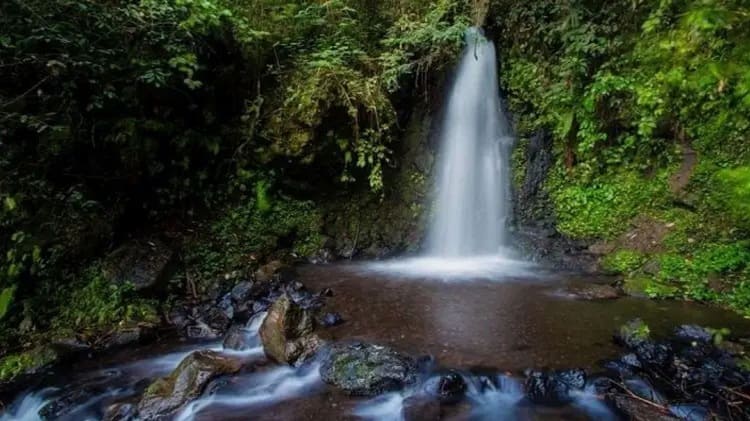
[0,264,750,421]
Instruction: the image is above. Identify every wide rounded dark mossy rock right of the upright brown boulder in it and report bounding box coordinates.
[320,343,417,396]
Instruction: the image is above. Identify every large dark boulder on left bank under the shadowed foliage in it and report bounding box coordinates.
[102,239,174,290]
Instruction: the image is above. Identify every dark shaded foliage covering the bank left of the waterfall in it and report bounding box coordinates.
[0,0,472,377]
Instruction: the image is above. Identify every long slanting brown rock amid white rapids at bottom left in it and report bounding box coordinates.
[138,350,242,420]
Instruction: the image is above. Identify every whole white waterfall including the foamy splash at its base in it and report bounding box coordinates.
[365,28,535,281]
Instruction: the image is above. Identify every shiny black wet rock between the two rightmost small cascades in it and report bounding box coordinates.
[524,369,586,405]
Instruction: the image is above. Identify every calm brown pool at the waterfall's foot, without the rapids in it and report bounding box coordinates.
[299,264,750,371]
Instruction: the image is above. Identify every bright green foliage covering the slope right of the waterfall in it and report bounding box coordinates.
[493,0,750,313]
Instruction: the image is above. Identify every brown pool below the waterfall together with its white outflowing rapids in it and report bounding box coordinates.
[0,263,750,421]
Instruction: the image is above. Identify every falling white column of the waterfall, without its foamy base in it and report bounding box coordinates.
[427,28,513,258]
